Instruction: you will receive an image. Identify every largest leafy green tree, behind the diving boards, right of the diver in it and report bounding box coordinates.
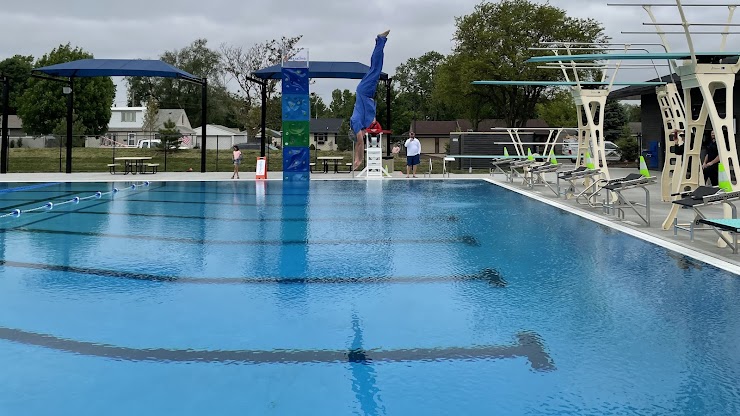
[435,0,608,127]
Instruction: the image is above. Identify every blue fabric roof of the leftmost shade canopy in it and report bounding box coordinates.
[34,59,202,83]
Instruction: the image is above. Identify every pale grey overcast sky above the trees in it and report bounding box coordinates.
[0,0,740,106]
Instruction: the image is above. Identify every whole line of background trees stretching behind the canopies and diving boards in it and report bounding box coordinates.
[0,0,639,150]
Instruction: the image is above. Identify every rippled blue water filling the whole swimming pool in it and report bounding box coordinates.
[0,181,740,415]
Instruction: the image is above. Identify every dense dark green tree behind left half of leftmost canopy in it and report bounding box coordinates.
[17,44,116,135]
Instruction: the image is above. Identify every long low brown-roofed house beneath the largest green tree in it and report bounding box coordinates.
[410,119,549,154]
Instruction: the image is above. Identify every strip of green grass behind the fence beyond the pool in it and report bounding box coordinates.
[8,147,450,174]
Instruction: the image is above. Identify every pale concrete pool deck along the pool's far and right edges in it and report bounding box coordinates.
[2,165,740,275]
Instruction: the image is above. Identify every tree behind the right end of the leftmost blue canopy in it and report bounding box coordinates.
[126,39,229,126]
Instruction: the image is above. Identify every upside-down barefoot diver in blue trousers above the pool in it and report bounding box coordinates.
[349,30,390,170]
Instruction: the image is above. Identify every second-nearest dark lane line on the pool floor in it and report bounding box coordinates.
[0,260,508,287]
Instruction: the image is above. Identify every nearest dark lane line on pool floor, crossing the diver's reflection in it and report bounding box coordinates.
[0,327,555,371]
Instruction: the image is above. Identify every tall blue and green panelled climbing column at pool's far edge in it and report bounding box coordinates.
[282,61,311,181]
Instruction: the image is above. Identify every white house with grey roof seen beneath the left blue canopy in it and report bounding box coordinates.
[102,107,199,147]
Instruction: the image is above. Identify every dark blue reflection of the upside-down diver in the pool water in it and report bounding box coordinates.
[349,314,385,415]
